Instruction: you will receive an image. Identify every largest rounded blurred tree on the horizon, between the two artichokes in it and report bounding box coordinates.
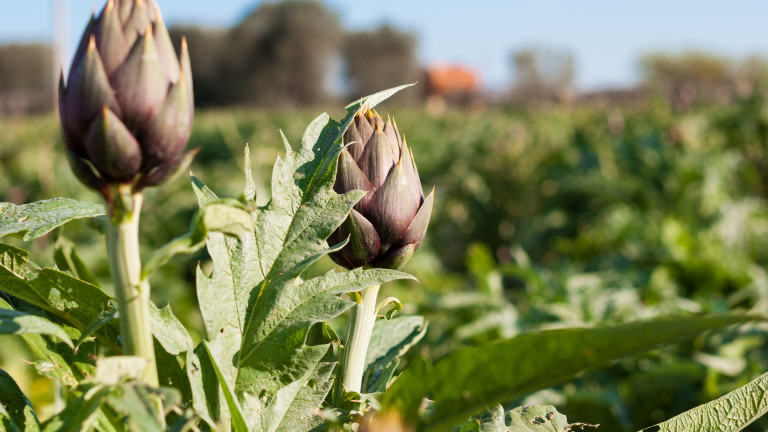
[219,0,342,105]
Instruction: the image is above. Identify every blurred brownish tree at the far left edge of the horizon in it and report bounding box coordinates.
[0,43,54,113]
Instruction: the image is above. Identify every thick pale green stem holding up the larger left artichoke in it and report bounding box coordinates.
[107,191,159,387]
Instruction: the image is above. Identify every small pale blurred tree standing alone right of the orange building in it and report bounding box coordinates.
[512,48,575,102]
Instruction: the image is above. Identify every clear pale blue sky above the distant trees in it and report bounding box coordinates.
[0,0,768,89]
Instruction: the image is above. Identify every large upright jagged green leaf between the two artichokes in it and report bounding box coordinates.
[188,85,409,425]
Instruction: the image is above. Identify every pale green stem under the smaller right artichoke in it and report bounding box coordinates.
[336,285,379,402]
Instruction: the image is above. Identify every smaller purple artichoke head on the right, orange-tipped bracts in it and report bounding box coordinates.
[328,108,434,269]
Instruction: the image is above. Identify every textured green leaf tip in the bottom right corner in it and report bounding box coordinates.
[642,373,768,432]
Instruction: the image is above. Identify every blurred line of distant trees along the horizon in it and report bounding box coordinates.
[0,0,768,113]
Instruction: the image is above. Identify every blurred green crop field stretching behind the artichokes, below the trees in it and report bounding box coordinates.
[0,92,768,431]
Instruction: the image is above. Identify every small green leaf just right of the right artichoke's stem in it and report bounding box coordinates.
[363,316,427,393]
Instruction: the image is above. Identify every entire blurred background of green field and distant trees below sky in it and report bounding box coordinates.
[0,0,768,431]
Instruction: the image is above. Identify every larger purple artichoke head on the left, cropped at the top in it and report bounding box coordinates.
[59,0,197,196]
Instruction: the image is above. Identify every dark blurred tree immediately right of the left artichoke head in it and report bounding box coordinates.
[168,26,230,106]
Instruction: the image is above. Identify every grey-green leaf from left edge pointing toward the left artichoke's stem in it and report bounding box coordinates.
[0,198,106,241]
